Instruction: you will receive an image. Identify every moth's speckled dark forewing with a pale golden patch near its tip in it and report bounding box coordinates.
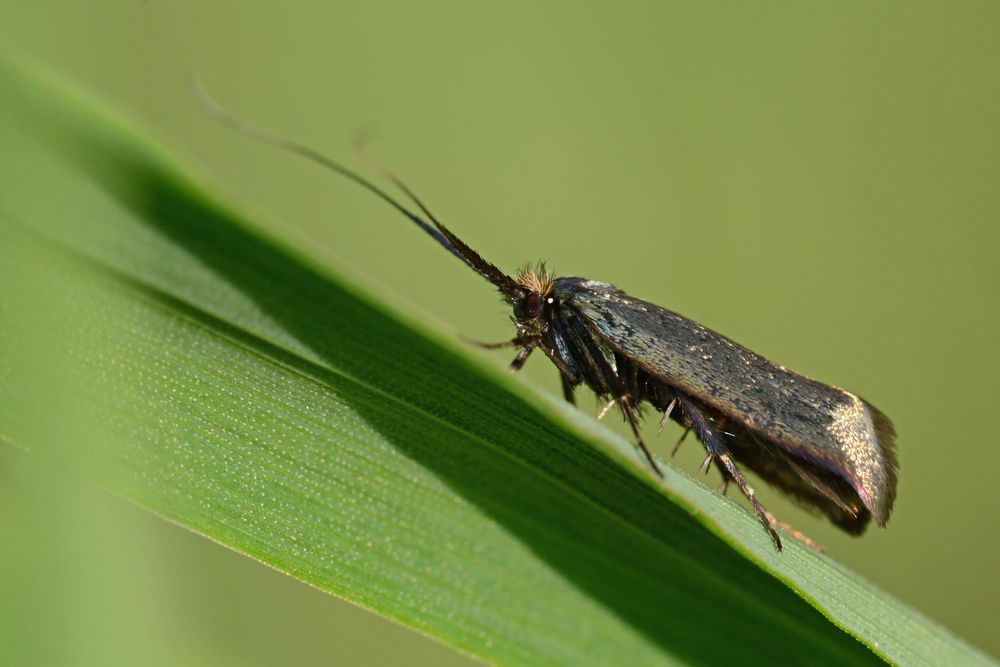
[555,278,896,525]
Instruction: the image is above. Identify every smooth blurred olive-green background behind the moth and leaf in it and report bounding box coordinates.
[0,0,1000,665]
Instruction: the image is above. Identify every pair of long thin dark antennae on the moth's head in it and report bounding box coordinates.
[190,76,518,294]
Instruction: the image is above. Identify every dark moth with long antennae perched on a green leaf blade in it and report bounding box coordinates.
[195,88,897,551]
